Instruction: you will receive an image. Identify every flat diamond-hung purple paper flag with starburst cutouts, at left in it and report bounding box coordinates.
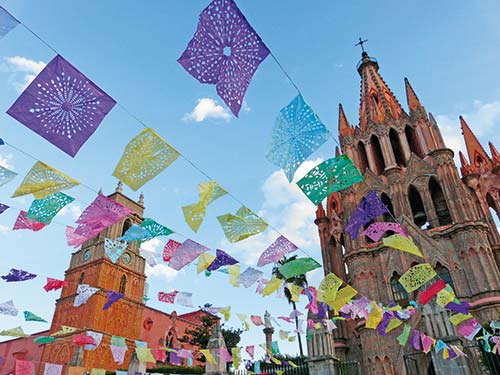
[7,55,115,156]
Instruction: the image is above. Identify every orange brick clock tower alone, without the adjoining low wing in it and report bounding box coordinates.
[42,182,146,371]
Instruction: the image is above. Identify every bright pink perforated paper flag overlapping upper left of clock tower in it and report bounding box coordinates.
[75,194,131,234]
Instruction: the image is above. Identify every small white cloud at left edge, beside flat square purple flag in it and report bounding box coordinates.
[0,56,47,92]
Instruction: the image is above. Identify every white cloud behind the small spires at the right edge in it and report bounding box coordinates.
[436,100,500,165]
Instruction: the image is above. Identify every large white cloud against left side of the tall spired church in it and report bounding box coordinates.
[229,159,322,264]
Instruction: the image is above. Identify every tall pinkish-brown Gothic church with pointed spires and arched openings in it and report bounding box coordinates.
[315,52,500,375]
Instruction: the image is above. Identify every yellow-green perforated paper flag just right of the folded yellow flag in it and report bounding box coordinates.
[217,206,267,243]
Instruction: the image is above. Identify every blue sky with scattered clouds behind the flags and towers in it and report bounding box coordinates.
[0,0,500,364]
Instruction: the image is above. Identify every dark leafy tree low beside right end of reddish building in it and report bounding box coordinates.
[179,315,243,362]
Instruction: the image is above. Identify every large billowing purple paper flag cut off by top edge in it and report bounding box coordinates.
[178,0,270,117]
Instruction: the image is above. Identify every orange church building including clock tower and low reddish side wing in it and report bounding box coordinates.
[0,187,216,375]
